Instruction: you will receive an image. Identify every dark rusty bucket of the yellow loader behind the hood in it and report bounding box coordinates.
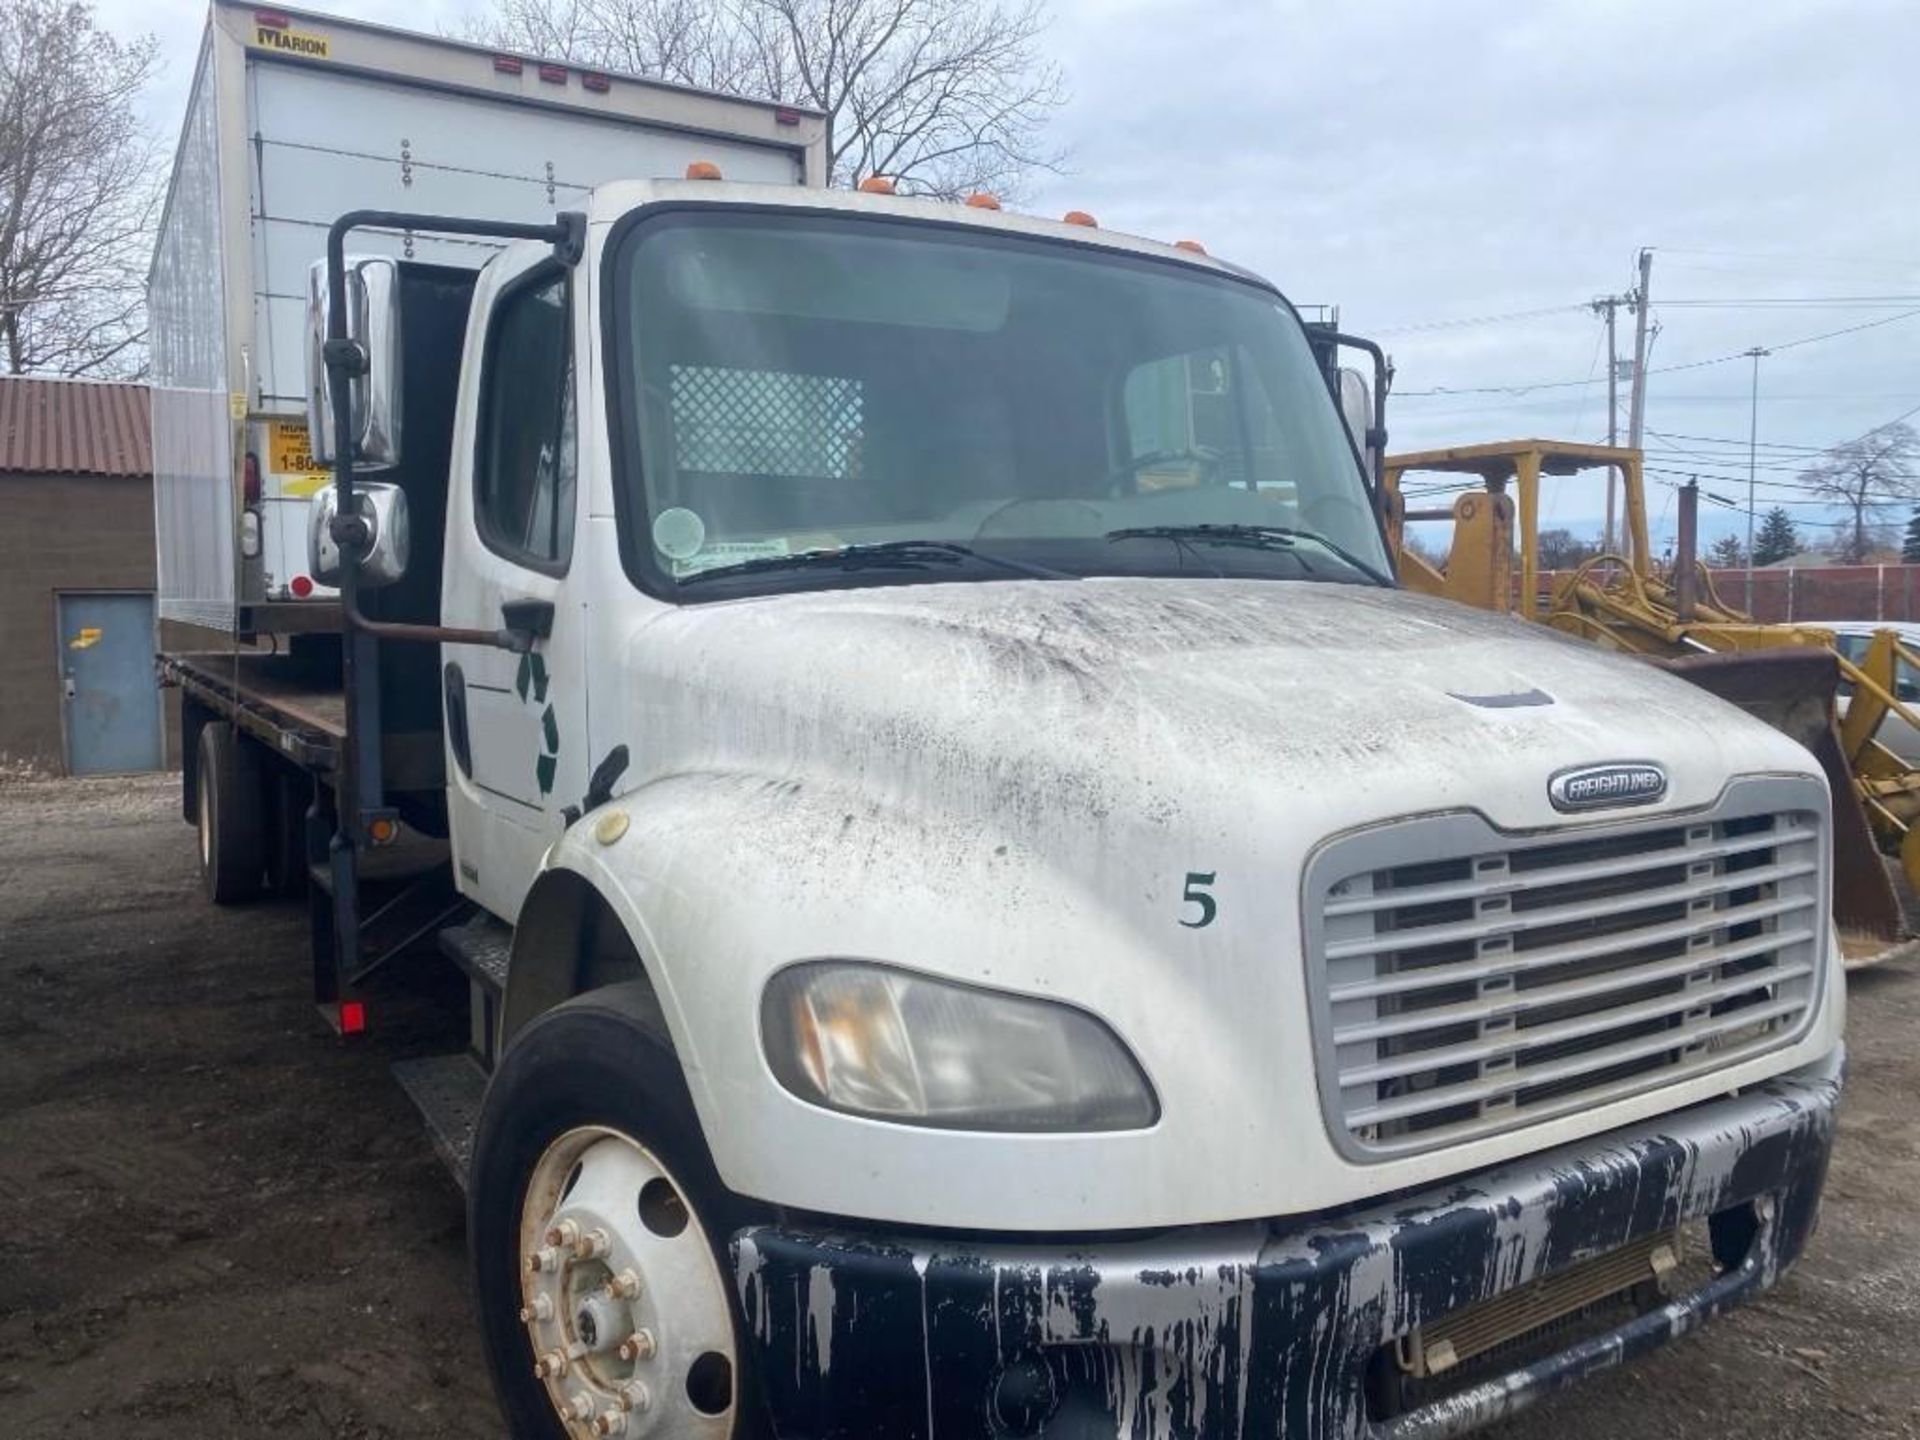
[1653,647,1907,960]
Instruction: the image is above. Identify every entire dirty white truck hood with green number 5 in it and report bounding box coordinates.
[587,580,1839,1231]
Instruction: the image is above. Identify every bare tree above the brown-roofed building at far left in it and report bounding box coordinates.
[0,0,163,374]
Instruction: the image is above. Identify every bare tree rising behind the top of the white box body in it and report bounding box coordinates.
[470,0,1066,198]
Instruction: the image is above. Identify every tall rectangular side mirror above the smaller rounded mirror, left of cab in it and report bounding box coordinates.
[307,255,399,468]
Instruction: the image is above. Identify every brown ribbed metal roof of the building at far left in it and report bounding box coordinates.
[0,374,154,478]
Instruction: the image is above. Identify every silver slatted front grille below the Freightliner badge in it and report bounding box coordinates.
[1308,780,1826,1158]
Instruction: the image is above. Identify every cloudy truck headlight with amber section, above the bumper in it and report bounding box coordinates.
[760,960,1160,1131]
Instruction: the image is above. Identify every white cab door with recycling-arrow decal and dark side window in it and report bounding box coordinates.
[440,257,588,920]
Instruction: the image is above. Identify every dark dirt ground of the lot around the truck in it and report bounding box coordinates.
[0,778,1920,1440]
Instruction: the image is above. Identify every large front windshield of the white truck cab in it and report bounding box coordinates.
[609,211,1388,599]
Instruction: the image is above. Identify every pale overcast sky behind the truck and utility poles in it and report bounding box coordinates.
[98,0,1920,534]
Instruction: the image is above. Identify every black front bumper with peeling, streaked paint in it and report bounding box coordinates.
[733,1052,1841,1440]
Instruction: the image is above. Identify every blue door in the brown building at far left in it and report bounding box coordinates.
[56,591,159,776]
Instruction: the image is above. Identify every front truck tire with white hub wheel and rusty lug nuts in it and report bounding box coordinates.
[467,983,764,1440]
